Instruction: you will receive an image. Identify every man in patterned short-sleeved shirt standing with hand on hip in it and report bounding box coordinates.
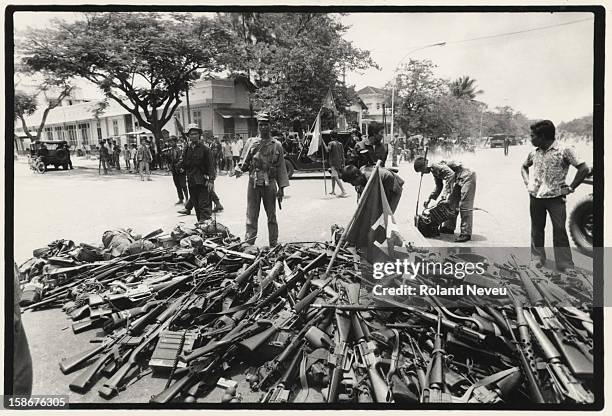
[521,120,589,271]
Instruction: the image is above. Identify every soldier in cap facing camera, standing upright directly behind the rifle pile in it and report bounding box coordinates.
[235,113,289,247]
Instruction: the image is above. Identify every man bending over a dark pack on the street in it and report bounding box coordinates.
[414,156,476,243]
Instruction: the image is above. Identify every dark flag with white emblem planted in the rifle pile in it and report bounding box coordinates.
[346,166,406,263]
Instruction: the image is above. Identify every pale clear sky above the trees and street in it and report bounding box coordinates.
[14,12,593,123]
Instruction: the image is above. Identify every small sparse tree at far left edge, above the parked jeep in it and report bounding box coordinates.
[13,73,74,141]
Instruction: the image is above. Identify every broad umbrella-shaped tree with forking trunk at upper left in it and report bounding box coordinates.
[23,12,235,151]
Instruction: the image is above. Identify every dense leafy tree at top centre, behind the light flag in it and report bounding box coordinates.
[220,13,376,129]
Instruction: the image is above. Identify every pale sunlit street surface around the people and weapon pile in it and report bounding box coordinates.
[14,141,592,403]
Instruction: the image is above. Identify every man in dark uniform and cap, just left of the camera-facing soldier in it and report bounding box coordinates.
[183,124,215,222]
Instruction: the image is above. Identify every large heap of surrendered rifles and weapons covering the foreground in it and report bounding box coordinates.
[20,225,594,405]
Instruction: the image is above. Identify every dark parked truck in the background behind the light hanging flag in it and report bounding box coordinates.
[283,130,357,178]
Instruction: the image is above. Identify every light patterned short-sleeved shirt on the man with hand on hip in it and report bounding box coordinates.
[524,140,584,198]
